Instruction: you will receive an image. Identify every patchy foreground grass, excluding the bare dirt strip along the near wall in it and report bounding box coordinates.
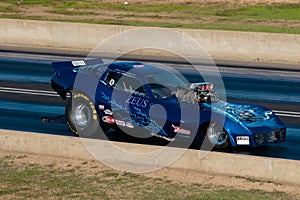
[0,156,293,200]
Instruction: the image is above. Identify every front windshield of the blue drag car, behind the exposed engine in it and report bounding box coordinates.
[147,72,189,98]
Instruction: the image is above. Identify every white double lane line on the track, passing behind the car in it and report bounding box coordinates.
[0,87,300,118]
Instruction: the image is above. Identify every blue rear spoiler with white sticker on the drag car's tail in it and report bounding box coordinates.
[52,58,103,75]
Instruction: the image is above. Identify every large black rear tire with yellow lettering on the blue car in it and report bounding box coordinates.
[65,92,110,138]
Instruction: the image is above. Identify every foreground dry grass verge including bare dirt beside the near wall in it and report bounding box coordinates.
[0,151,299,200]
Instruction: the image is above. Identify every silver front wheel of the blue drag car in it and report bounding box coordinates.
[207,124,228,146]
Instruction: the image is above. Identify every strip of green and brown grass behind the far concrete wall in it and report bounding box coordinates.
[0,0,300,34]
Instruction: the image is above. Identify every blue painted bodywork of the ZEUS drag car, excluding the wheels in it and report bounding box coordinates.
[51,61,286,146]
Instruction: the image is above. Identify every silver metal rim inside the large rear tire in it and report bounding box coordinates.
[74,105,91,127]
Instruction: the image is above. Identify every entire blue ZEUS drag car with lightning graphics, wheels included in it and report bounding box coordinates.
[51,59,286,149]
